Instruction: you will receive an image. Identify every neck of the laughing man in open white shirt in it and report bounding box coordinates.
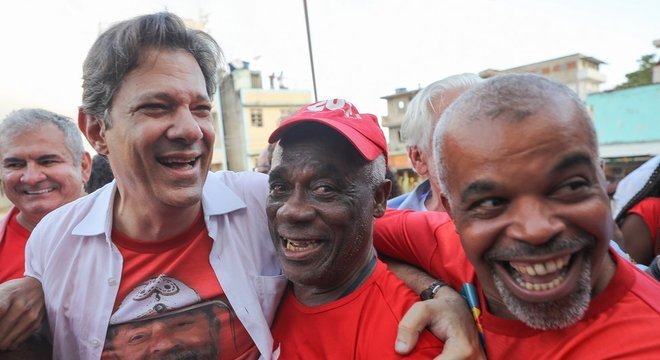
[112,192,202,241]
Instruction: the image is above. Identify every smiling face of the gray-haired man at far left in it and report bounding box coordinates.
[0,123,90,230]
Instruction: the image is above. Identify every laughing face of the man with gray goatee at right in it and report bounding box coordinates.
[443,100,613,329]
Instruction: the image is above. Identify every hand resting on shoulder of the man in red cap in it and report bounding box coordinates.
[396,286,486,360]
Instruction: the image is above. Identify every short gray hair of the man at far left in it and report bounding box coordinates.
[0,109,85,166]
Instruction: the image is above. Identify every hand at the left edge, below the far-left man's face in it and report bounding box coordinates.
[0,276,45,350]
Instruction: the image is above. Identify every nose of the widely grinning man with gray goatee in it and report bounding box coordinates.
[506,199,566,245]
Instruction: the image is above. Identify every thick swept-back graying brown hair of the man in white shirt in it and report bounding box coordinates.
[82,12,222,128]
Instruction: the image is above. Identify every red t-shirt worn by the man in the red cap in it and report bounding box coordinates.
[271,261,443,360]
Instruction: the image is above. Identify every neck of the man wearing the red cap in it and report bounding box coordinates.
[293,248,376,306]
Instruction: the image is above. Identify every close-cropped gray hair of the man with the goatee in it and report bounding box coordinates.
[433,74,598,197]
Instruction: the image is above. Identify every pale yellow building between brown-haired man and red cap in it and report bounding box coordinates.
[217,60,312,171]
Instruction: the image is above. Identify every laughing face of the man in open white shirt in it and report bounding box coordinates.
[88,49,215,217]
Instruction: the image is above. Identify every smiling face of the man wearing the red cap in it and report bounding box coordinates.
[266,129,389,295]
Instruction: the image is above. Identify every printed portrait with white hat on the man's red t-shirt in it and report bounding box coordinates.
[102,275,258,360]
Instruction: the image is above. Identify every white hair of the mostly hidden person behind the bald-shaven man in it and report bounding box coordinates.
[401,73,483,154]
